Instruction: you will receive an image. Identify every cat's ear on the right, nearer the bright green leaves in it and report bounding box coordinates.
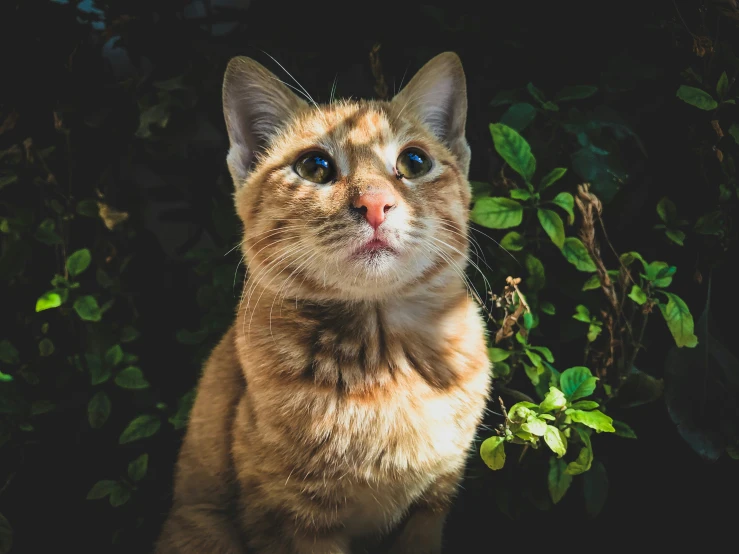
[393,52,470,175]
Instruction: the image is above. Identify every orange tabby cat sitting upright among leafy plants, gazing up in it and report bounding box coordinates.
[156,52,491,554]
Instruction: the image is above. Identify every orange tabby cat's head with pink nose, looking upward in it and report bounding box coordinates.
[223,52,470,300]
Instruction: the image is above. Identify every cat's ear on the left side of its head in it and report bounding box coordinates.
[223,56,307,187]
